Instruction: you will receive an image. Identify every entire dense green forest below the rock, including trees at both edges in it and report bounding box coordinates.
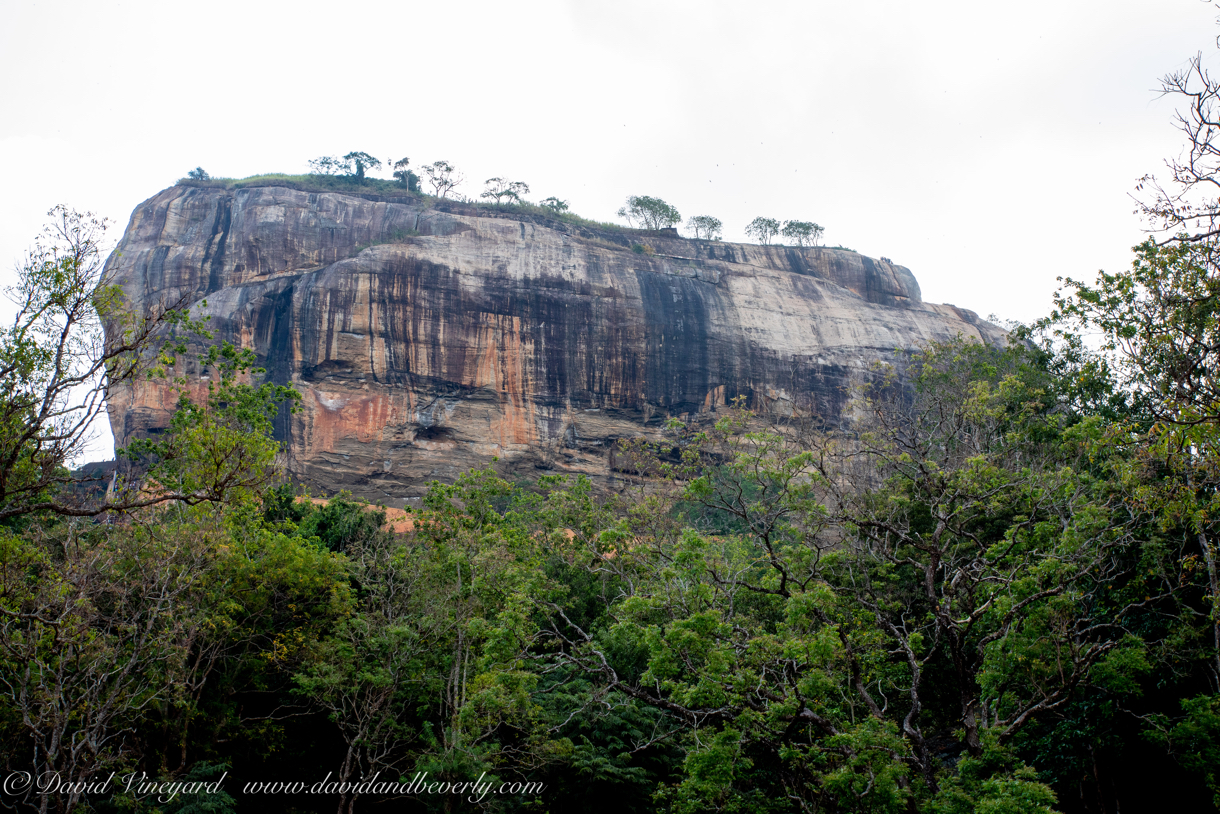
[7,61,1220,814]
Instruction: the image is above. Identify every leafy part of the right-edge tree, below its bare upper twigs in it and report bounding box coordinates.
[1039,230,1220,810]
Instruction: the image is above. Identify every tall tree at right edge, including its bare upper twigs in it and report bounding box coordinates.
[1039,35,1220,801]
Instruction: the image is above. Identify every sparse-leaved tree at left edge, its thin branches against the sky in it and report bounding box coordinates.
[0,206,298,521]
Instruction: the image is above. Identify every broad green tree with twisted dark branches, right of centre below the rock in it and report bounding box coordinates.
[539,340,1156,812]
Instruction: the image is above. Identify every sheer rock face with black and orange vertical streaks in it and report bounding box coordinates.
[102,187,1003,505]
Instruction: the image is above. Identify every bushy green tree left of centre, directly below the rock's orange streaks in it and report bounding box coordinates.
[294,471,558,814]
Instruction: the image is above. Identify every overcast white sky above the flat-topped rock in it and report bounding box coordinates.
[0,0,1220,458]
